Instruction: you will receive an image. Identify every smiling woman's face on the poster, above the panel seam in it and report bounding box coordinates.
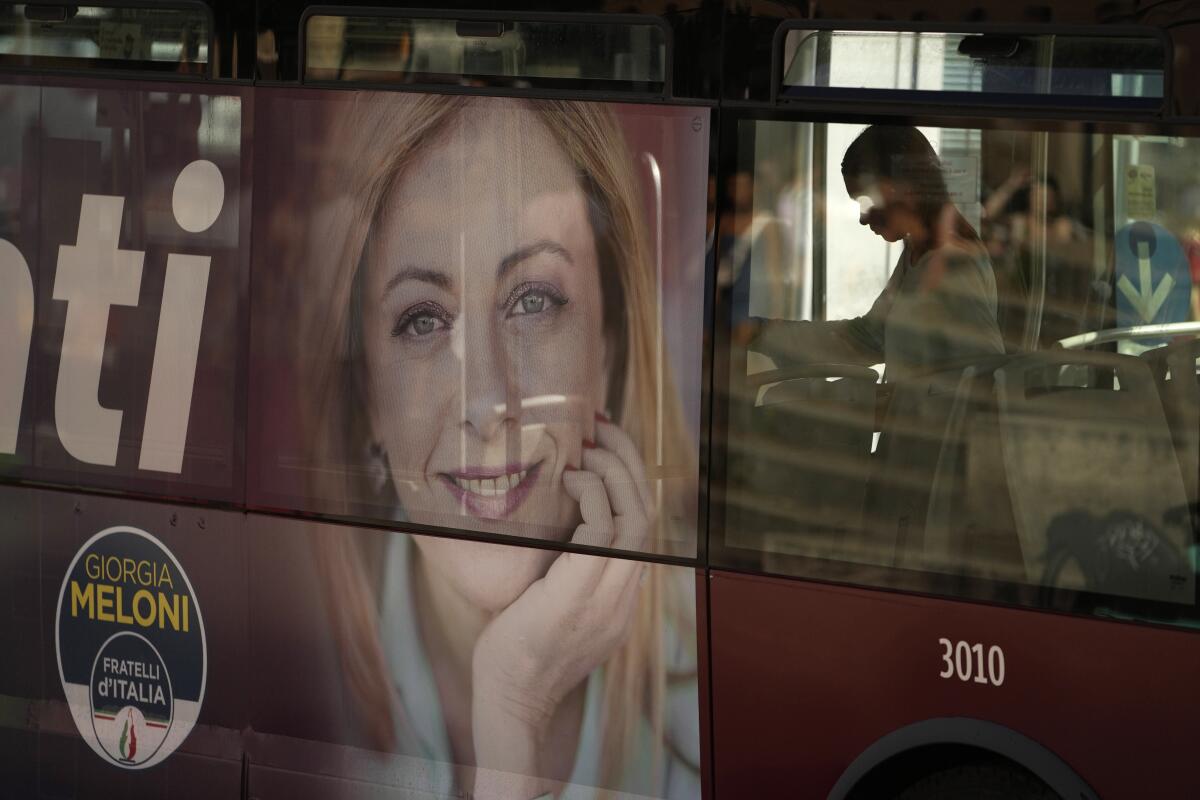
[361,104,607,599]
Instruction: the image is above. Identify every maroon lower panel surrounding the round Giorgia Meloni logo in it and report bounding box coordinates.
[0,487,247,799]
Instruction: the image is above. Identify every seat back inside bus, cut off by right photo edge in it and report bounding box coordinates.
[1141,339,1200,510]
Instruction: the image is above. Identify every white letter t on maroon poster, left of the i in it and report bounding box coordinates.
[54,194,145,467]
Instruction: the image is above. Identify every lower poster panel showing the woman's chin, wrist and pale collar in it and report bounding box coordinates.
[246,515,701,800]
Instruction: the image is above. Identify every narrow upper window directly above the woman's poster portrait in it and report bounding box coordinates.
[304,11,668,94]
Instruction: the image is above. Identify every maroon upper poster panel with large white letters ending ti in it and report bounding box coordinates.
[0,78,251,503]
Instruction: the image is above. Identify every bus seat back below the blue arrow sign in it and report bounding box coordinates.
[995,350,1194,601]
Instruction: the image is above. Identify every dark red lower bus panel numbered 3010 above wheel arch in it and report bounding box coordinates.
[709,572,1200,798]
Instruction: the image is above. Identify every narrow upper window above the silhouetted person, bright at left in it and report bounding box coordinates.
[782,30,1166,108]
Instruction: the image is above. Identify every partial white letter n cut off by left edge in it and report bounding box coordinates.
[0,239,34,453]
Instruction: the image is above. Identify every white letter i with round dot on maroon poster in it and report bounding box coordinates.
[138,161,224,473]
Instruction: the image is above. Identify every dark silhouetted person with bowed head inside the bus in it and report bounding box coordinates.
[748,125,1004,381]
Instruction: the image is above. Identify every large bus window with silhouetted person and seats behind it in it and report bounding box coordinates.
[720,110,1200,619]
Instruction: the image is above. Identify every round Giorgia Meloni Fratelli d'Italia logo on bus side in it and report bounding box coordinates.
[54,525,208,769]
